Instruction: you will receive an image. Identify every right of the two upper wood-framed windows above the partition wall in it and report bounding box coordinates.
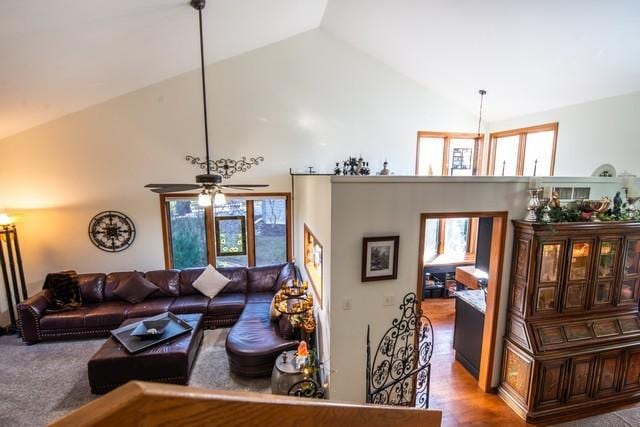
[487,123,558,176]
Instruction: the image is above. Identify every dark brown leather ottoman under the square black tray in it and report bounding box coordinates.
[88,314,203,394]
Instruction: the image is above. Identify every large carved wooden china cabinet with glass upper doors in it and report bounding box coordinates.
[498,221,640,422]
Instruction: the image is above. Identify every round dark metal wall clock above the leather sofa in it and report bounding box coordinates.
[89,211,136,252]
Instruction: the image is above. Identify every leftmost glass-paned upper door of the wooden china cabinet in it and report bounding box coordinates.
[533,241,566,313]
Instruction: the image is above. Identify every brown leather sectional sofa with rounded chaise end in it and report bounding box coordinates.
[18,264,298,376]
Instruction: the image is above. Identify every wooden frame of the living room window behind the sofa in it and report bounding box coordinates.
[160,193,293,269]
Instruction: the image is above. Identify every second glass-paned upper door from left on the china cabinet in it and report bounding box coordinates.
[562,239,595,311]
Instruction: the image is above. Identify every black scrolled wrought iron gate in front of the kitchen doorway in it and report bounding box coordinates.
[366,292,433,409]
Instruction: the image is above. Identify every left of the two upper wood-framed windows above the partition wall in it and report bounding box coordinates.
[416,131,484,176]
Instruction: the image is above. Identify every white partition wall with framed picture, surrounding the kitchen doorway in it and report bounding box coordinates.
[330,177,620,403]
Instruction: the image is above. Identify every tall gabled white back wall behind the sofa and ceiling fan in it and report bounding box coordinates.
[0,30,475,324]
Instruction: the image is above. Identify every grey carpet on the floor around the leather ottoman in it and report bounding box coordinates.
[0,328,270,427]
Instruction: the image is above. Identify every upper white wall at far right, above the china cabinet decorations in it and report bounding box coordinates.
[488,92,640,176]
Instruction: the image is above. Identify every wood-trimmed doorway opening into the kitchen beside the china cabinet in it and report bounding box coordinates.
[417,212,507,392]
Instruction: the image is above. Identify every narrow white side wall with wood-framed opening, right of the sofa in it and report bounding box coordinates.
[293,176,332,390]
